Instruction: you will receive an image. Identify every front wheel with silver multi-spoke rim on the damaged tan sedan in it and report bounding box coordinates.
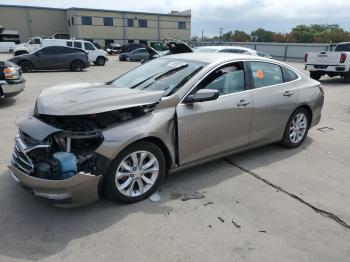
[103,142,166,203]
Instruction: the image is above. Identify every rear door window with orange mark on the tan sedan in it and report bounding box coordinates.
[250,62,283,88]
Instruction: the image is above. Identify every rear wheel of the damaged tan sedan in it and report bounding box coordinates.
[281,108,311,148]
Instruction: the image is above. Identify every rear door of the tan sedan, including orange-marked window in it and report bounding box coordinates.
[249,61,299,144]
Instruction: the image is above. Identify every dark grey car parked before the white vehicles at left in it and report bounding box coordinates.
[9,46,90,72]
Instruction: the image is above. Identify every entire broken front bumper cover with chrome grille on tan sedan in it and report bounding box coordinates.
[8,115,108,207]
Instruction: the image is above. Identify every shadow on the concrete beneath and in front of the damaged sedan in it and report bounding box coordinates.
[0,138,312,260]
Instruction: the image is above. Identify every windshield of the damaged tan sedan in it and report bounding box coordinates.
[109,58,205,95]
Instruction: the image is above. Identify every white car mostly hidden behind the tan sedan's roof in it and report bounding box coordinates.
[194,46,271,58]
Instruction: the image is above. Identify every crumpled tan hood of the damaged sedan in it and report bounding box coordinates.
[35,83,164,116]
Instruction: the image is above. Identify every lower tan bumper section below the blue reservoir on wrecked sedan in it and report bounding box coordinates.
[8,164,101,207]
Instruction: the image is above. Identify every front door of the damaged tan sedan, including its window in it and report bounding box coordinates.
[176,62,252,165]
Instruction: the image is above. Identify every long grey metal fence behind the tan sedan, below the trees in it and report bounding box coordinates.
[189,41,330,61]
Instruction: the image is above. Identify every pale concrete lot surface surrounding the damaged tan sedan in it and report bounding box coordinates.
[0,55,350,262]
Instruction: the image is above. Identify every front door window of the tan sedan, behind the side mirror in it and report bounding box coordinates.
[197,62,244,95]
